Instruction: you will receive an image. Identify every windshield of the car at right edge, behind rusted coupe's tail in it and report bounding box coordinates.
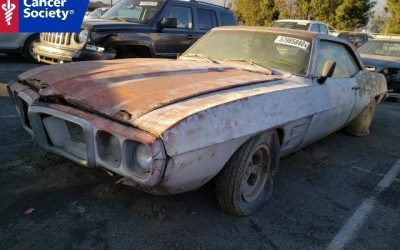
[358,41,400,57]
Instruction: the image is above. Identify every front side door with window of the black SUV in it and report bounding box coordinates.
[154,4,201,57]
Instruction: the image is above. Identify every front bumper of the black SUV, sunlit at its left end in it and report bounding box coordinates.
[33,42,116,64]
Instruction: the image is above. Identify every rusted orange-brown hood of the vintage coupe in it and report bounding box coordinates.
[20,59,278,124]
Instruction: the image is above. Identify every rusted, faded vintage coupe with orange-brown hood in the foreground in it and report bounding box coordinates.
[10,27,387,216]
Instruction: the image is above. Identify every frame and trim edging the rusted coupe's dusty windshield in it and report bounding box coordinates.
[178,28,315,78]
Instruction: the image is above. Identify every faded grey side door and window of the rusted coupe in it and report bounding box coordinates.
[306,40,363,141]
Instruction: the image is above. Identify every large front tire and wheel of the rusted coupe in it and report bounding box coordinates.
[216,131,280,216]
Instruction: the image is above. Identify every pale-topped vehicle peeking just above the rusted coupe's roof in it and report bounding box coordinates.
[272,19,329,34]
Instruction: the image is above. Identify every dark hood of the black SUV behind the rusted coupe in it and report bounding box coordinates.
[82,19,150,31]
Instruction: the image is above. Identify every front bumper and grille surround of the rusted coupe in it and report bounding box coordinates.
[10,83,166,188]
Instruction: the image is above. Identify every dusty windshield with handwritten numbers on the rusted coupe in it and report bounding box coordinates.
[180,30,312,75]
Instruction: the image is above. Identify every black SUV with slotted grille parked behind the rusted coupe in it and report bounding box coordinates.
[33,0,237,64]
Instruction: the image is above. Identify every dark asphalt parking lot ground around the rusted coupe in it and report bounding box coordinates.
[0,55,400,249]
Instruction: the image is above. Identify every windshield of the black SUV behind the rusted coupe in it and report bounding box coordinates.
[102,0,164,23]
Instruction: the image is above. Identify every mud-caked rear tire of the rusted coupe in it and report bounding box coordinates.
[345,99,376,137]
